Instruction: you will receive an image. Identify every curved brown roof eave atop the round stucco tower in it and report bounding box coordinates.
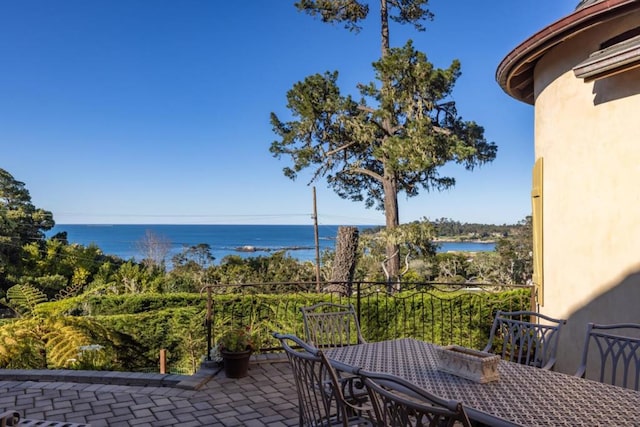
[496,0,640,105]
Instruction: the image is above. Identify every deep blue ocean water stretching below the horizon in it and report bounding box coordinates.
[46,224,495,263]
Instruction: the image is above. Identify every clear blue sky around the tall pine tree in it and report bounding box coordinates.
[0,0,578,225]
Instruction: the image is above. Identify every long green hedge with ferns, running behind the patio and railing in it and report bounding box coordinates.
[0,285,529,372]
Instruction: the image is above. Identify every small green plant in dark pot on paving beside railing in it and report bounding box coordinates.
[217,328,253,378]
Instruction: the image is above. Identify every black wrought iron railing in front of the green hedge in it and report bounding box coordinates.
[205,282,535,358]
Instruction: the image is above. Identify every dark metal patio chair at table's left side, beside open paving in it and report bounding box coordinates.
[273,332,373,427]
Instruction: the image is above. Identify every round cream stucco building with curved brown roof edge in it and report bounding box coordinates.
[496,0,640,373]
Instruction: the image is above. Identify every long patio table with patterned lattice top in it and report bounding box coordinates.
[325,338,640,427]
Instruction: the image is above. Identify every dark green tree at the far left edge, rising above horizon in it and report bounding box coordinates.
[0,168,55,295]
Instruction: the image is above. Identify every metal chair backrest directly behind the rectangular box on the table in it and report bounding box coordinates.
[484,310,567,369]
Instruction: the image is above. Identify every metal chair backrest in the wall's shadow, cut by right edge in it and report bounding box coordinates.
[576,323,640,391]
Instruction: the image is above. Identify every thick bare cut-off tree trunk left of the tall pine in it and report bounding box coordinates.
[326,227,359,295]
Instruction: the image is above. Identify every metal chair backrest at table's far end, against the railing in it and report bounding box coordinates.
[300,302,365,348]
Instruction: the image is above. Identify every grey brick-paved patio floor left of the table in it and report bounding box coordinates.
[0,358,298,427]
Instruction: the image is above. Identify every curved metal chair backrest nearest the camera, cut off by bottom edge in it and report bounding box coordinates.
[358,370,471,427]
